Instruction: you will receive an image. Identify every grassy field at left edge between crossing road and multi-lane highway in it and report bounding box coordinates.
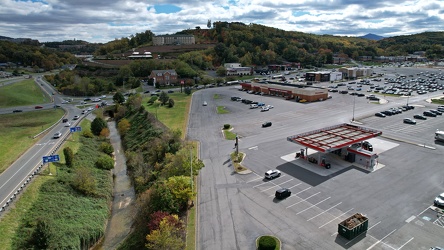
[0,109,64,173]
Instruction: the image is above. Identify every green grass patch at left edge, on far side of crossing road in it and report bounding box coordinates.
[0,79,49,108]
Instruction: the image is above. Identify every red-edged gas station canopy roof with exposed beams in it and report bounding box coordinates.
[287,123,382,153]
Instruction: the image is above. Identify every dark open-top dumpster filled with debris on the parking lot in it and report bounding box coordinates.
[338,213,368,240]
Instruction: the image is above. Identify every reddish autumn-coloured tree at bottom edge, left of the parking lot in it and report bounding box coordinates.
[145,215,185,250]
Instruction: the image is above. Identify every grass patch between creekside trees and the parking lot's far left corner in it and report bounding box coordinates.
[143,93,191,138]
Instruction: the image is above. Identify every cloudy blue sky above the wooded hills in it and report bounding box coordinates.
[0,0,444,43]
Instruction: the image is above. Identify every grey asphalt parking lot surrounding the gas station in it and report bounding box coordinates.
[193,66,444,249]
